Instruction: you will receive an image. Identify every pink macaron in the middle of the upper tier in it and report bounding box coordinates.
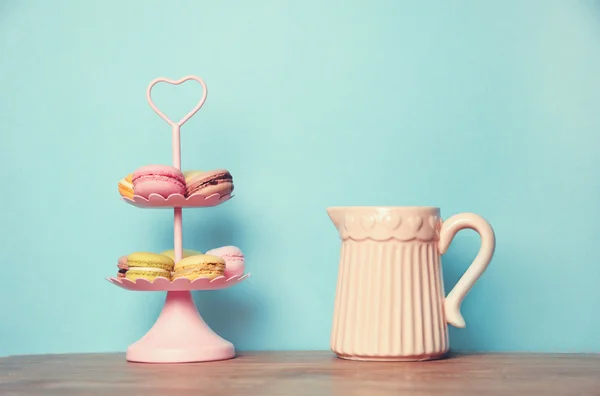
[132,165,186,198]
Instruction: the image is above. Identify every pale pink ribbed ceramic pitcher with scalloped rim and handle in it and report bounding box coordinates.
[327,207,495,361]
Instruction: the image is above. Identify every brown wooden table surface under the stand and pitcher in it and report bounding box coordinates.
[0,352,600,396]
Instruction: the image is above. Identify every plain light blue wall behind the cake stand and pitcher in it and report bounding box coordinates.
[0,0,600,354]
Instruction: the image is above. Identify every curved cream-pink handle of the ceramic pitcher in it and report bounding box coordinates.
[439,213,496,328]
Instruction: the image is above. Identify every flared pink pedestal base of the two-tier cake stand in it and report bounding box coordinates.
[127,291,235,363]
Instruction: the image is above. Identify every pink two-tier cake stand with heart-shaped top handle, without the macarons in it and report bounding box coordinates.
[107,76,250,363]
